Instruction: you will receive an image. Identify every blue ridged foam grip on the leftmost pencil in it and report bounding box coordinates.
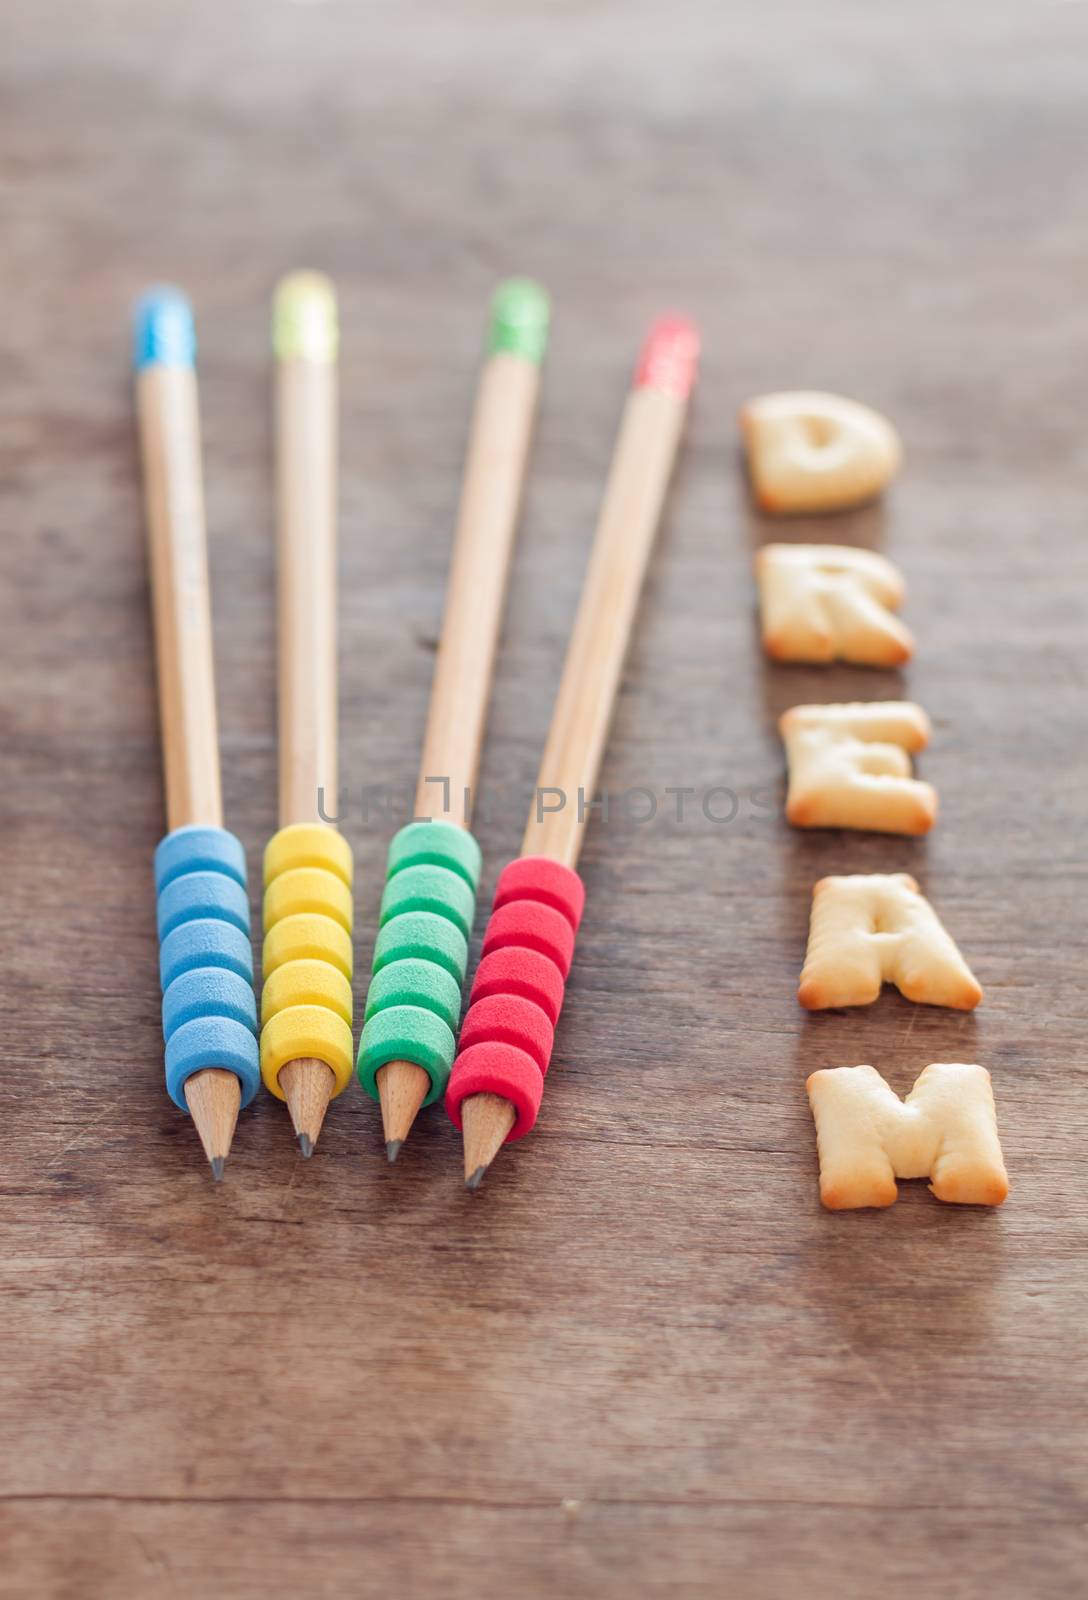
[155,827,261,1110]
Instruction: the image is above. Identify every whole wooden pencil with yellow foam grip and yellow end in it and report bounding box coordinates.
[261,272,354,1157]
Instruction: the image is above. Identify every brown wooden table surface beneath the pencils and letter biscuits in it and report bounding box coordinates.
[0,0,1088,1600]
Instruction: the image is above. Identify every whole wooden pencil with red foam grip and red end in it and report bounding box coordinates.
[446,318,699,1189]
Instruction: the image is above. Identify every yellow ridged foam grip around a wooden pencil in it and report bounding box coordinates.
[261,822,354,1099]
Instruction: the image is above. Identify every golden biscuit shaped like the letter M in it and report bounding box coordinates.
[805,1061,1008,1211]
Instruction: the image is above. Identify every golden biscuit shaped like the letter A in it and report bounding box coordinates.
[797,872,982,1011]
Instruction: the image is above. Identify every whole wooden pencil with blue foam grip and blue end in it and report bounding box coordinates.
[134,288,259,1179]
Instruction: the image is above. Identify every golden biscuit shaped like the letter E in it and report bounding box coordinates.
[778,701,938,834]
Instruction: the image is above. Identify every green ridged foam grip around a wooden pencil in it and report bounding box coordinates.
[358,819,480,1106]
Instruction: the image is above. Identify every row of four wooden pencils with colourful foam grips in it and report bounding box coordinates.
[134,272,698,1189]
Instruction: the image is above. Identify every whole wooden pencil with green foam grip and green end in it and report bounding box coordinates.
[358,278,549,1162]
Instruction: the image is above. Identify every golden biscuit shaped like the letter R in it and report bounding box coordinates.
[755,544,914,667]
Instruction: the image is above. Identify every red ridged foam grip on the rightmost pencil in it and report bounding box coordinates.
[446,856,586,1142]
